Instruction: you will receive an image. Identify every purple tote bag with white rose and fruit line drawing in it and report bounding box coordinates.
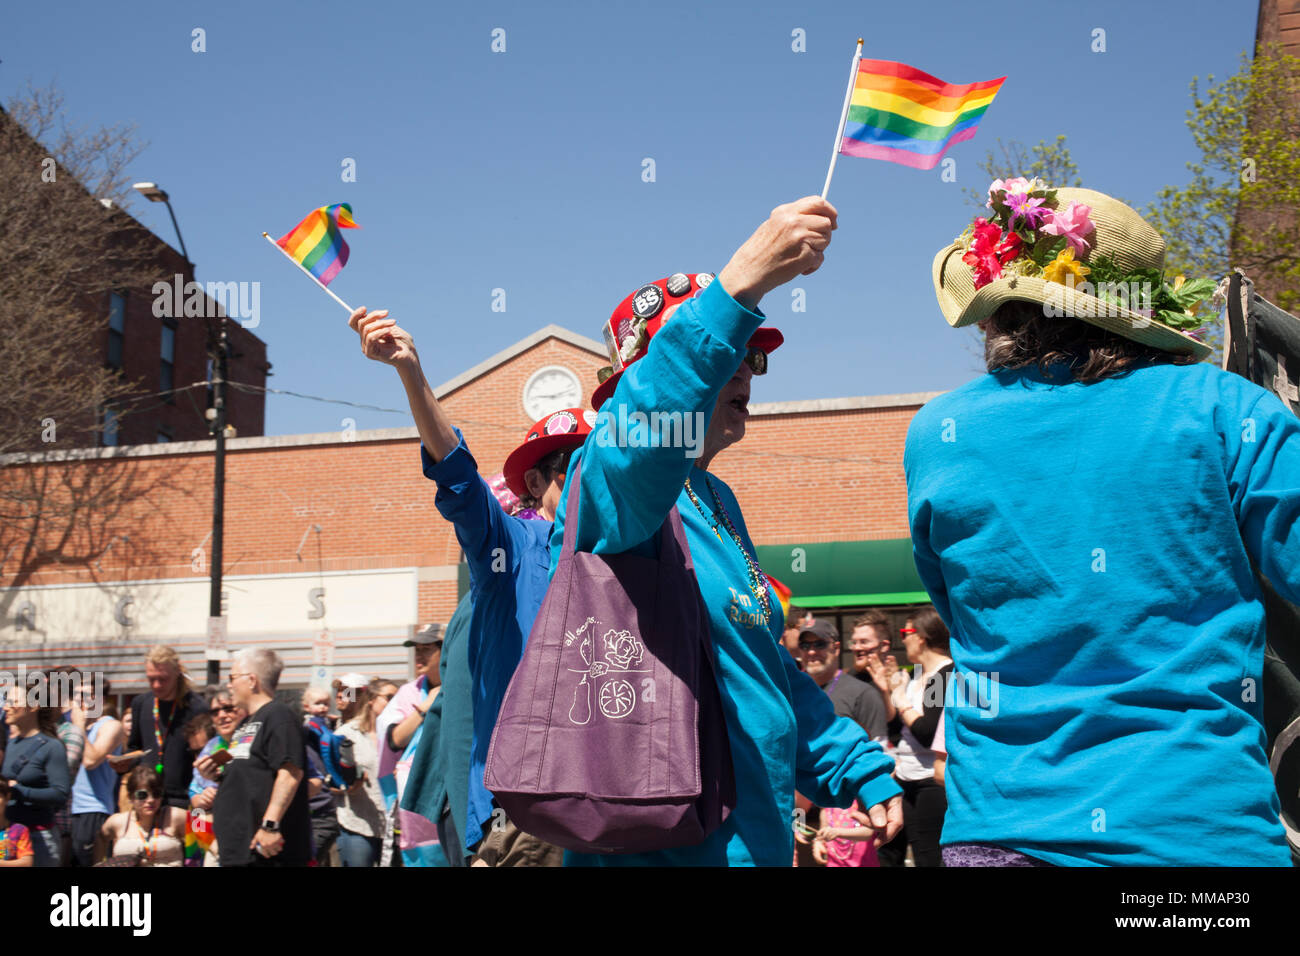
[484,467,736,853]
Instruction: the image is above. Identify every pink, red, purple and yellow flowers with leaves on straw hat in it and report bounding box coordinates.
[957,177,1216,333]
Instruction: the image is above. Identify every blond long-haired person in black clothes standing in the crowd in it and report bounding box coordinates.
[115,644,208,809]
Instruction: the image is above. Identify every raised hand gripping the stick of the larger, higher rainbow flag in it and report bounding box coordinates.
[718,196,839,308]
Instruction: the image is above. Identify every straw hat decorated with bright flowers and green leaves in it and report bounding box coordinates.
[933,178,1214,358]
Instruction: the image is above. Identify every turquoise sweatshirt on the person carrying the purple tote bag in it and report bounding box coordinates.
[551,281,900,866]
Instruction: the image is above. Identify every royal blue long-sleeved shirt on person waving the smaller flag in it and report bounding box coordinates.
[420,429,551,849]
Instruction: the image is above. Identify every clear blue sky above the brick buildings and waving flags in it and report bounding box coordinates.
[0,0,1256,434]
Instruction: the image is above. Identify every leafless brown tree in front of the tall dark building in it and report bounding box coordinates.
[0,82,157,454]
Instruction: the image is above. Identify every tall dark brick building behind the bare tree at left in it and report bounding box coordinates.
[0,102,270,451]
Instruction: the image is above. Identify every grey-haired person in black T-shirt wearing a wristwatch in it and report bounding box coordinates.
[198,648,312,866]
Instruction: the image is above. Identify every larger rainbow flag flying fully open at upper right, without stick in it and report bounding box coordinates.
[840,60,1006,169]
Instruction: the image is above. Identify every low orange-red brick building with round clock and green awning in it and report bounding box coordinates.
[0,325,932,693]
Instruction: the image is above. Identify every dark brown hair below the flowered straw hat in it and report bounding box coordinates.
[979,302,1197,385]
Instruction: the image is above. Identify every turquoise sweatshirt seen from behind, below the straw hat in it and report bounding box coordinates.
[904,364,1300,866]
